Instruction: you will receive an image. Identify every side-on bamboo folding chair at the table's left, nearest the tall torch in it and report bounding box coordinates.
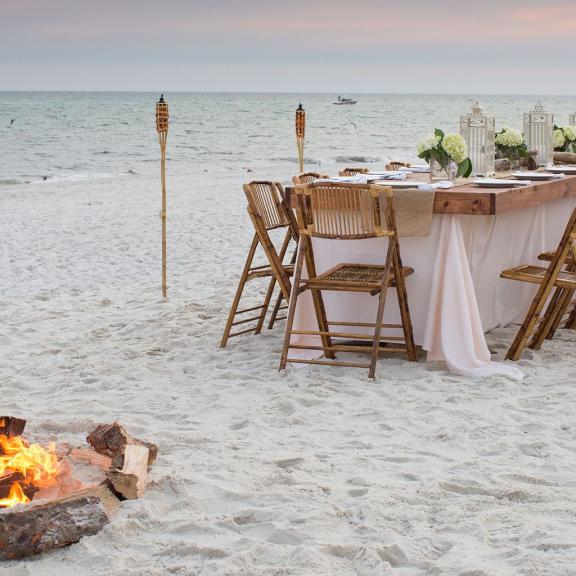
[220,182,299,348]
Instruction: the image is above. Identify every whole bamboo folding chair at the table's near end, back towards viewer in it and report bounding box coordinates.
[280,183,416,378]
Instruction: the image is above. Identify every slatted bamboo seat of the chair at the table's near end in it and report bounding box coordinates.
[304,264,414,292]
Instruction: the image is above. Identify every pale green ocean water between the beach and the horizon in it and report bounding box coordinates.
[0,92,576,187]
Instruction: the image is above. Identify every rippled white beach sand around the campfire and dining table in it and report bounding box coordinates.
[0,174,576,576]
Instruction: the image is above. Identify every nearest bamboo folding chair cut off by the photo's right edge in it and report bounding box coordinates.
[500,208,576,360]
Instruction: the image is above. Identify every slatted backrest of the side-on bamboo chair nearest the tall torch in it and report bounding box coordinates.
[244,181,294,230]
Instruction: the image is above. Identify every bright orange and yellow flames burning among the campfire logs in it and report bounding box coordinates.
[0,435,60,508]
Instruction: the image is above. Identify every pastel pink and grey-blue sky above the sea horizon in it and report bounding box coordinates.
[0,0,576,94]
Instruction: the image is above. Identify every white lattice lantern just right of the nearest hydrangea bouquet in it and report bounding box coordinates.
[460,102,496,176]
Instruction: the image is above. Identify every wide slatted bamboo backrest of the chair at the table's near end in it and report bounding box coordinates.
[295,182,396,240]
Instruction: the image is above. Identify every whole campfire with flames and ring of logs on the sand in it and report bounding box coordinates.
[0,417,158,560]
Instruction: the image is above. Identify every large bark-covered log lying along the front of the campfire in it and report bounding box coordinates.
[0,487,114,560]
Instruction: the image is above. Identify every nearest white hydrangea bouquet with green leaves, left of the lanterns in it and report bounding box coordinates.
[418,128,472,180]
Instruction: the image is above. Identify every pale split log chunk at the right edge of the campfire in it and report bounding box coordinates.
[108,444,150,500]
